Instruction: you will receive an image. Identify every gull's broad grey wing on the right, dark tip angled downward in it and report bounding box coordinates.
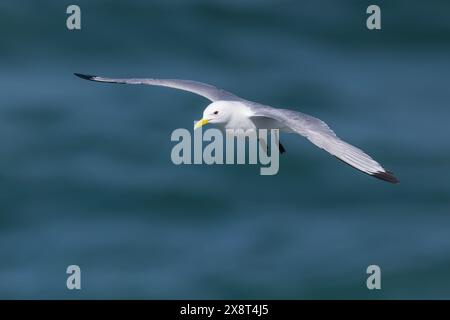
[249,103,398,183]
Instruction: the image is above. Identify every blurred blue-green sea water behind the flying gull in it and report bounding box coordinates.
[0,0,450,299]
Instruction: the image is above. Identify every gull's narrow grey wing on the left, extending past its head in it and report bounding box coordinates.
[75,73,243,102]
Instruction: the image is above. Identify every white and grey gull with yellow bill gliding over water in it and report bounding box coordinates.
[75,73,398,183]
